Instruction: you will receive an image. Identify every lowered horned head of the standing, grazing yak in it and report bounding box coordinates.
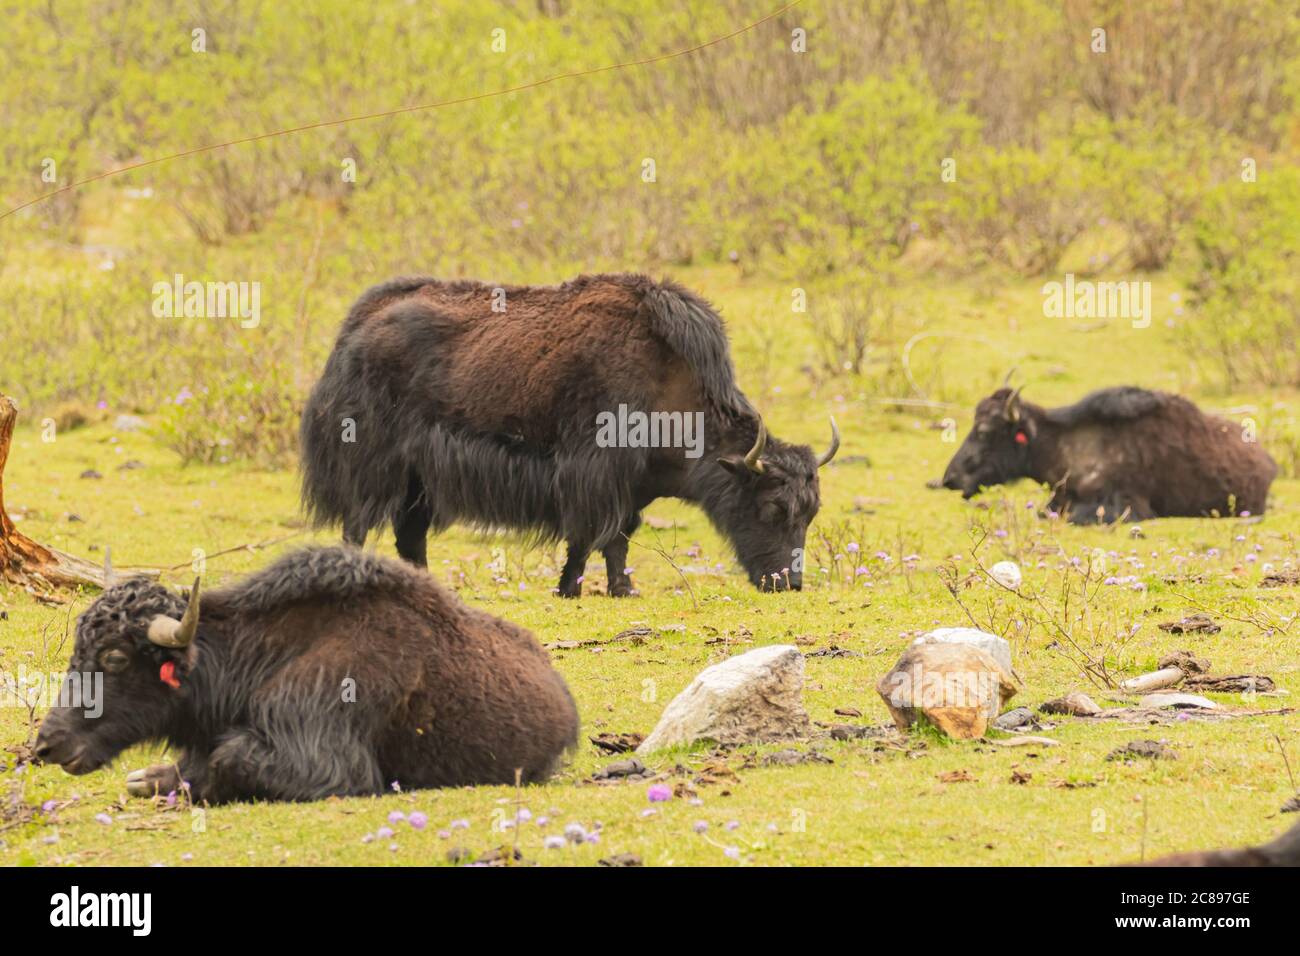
[710,419,840,591]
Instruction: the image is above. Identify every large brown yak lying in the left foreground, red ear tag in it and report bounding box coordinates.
[36,546,579,803]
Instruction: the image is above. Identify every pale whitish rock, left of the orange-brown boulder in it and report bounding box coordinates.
[637,644,811,753]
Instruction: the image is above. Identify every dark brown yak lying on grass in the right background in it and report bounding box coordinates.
[944,388,1278,524]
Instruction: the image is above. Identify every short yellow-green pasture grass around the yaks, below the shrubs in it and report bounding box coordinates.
[0,268,1300,865]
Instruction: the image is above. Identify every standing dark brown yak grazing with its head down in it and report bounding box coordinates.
[302,274,839,597]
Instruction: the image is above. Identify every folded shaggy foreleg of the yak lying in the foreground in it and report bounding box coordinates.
[195,719,384,804]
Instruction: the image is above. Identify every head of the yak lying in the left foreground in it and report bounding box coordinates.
[35,556,199,774]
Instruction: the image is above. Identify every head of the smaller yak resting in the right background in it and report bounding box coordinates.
[944,388,1037,498]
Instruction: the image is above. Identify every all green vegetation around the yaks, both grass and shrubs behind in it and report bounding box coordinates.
[0,0,1300,862]
